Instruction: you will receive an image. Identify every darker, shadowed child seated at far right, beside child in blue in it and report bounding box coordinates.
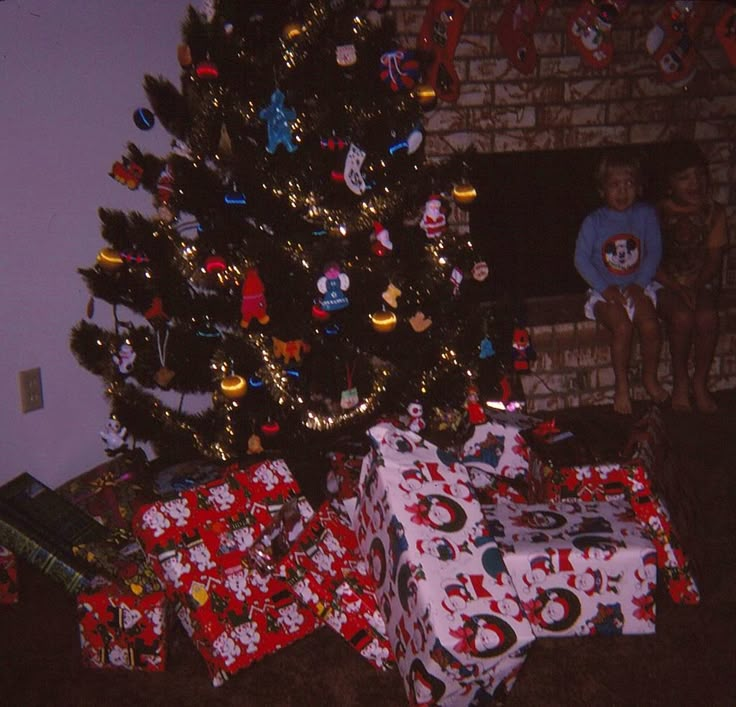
[657,143,727,413]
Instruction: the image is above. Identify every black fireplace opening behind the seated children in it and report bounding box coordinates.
[470,143,671,302]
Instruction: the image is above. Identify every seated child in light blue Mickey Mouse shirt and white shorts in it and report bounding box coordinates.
[575,152,668,415]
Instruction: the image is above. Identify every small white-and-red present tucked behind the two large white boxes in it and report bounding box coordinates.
[461,410,540,502]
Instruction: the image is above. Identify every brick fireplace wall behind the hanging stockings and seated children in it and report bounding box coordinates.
[391,0,736,411]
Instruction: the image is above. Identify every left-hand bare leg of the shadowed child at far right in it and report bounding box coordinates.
[657,288,695,412]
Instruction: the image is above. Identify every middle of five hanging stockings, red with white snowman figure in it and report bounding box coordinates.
[567,0,629,69]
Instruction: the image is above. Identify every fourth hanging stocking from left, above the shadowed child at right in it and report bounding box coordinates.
[646,0,710,86]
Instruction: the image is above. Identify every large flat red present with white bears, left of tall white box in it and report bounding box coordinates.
[133,460,316,686]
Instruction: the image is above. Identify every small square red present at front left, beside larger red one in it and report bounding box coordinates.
[77,582,168,671]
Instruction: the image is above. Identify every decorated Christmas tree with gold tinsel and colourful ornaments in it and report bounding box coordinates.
[71,0,510,459]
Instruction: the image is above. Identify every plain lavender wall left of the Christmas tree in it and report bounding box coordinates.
[0,0,190,486]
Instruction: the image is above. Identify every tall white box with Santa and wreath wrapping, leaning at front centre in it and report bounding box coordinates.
[354,424,534,705]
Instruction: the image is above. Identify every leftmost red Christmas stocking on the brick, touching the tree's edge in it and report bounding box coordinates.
[417,0,472,103]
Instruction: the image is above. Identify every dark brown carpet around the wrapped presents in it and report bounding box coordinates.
[0,391,736,707]
